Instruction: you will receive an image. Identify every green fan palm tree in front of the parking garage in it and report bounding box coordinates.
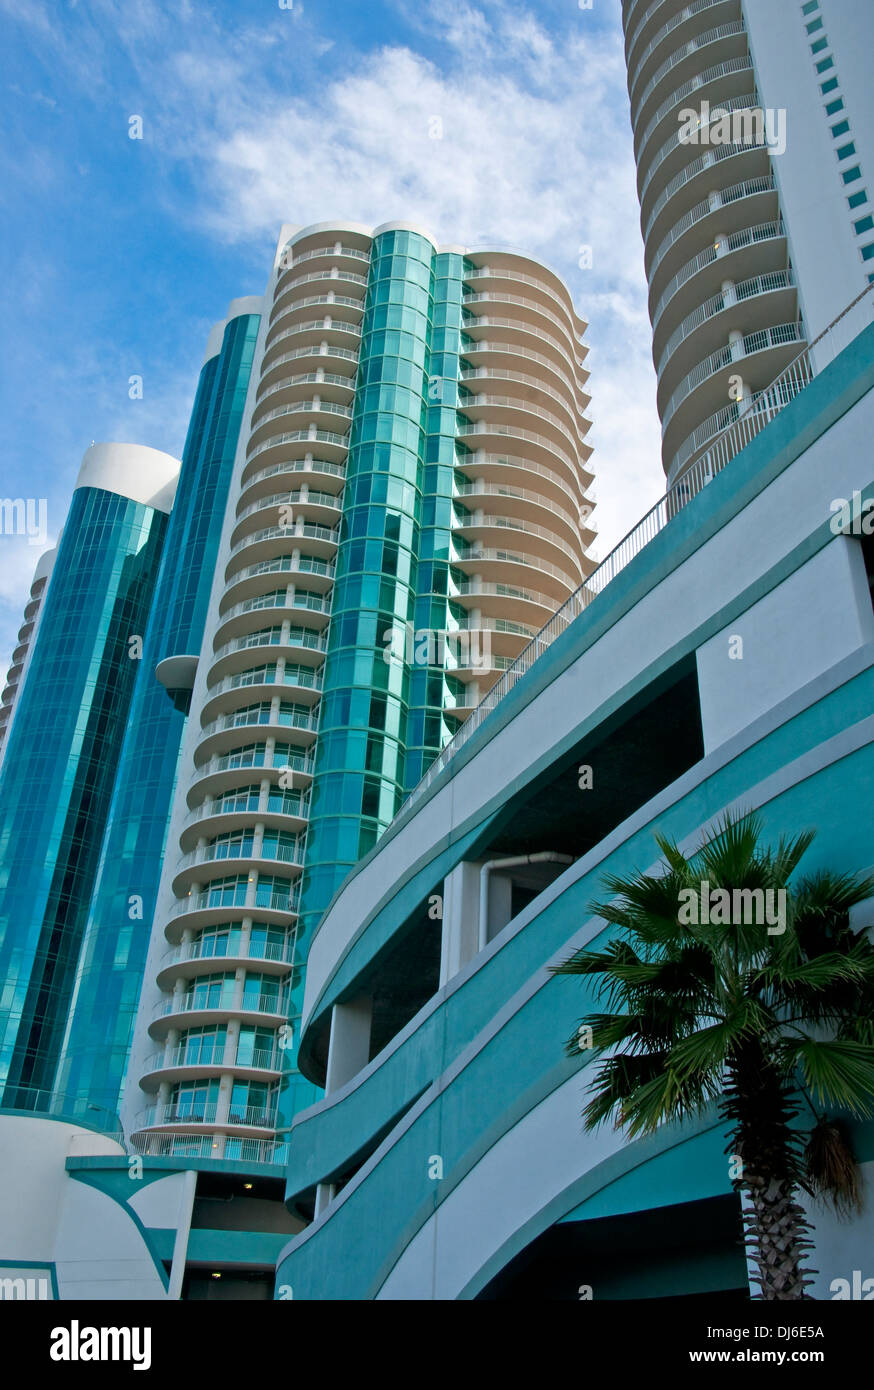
[553,815,874,1300]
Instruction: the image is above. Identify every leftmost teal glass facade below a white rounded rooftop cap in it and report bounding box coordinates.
[0,488,167,1109]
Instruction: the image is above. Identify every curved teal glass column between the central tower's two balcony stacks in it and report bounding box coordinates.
[300,231,436,941]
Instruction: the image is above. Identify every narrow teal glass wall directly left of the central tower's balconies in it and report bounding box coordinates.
[56,314,260,1125]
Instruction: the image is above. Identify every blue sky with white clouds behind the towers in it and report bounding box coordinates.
[0,0,663,671]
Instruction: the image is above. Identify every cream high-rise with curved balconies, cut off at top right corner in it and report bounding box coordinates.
[622,0,874,482]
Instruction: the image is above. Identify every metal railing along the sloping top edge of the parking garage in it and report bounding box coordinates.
[399,284,874,815]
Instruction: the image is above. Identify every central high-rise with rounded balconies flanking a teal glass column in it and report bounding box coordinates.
[117,225,592,1161]
